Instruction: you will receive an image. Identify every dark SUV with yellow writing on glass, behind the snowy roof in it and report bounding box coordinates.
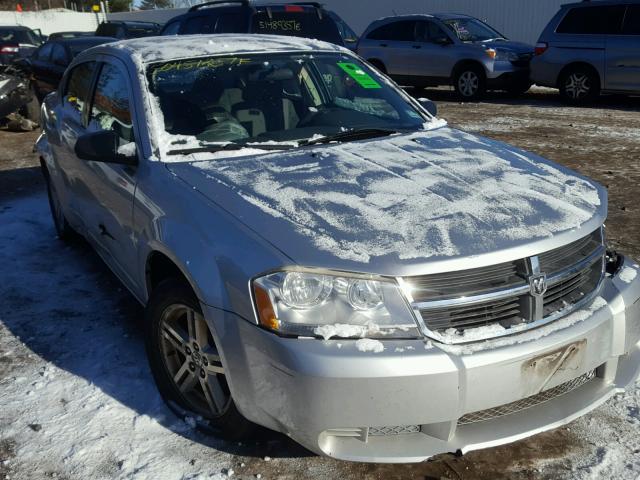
[161,0,357,49]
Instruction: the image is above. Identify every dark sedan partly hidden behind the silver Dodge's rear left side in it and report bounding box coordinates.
[25,37,116,101]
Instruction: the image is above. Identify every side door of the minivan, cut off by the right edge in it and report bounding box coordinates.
[605,4,640,92]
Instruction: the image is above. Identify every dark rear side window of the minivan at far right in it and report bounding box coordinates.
[556,5,625,35]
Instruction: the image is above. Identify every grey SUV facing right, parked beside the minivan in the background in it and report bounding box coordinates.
[358,14,534,100]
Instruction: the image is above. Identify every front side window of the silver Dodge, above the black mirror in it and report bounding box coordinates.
[89,63,134,146]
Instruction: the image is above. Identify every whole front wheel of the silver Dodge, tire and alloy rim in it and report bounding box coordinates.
[145,279,255,440]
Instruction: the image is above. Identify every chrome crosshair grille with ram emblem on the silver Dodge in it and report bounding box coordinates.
[403,229,605,343]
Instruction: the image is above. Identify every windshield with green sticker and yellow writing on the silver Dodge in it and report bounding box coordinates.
[147,53,428,149]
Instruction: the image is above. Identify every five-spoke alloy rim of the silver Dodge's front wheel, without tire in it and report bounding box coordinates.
[160,305,231,418]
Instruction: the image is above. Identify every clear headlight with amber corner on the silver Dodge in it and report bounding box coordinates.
[252,271,420,338]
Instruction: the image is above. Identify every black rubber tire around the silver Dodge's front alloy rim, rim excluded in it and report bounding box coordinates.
[145,278,256,440]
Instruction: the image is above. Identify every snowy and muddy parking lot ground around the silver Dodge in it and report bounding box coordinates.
[0,88,640,480]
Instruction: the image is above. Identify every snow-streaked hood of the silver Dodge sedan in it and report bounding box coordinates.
[166,127,607,275]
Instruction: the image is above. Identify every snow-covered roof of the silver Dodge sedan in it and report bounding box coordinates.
[105,34,348,63]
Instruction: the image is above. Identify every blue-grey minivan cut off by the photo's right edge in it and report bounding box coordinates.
[531,0,640,103]
